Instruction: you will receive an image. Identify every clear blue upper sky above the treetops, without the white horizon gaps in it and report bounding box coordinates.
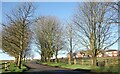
[2,2,77,20]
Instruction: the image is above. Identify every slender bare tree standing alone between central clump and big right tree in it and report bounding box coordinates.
[65,23,78,64]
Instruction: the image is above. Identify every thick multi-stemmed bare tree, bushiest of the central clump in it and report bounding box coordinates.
[35,16,59,63]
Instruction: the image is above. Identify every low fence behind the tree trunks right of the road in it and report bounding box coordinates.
[51,57,118,66]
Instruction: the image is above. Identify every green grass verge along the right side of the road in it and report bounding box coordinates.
[42,63,119,72]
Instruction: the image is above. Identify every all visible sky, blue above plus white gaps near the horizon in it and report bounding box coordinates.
[0,2,118,60]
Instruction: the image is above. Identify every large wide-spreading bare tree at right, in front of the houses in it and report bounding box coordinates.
[73,2,119,66]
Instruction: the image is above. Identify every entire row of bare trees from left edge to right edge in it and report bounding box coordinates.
[2,2,119,68]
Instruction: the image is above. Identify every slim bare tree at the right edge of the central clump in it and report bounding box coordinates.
[53,19,65,63]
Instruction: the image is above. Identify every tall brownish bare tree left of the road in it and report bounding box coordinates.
[2,3,35,68]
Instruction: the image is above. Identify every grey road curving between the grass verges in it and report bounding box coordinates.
[25,62,91,74]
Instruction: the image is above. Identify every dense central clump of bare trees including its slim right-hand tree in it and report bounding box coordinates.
[35,16,64,63]
